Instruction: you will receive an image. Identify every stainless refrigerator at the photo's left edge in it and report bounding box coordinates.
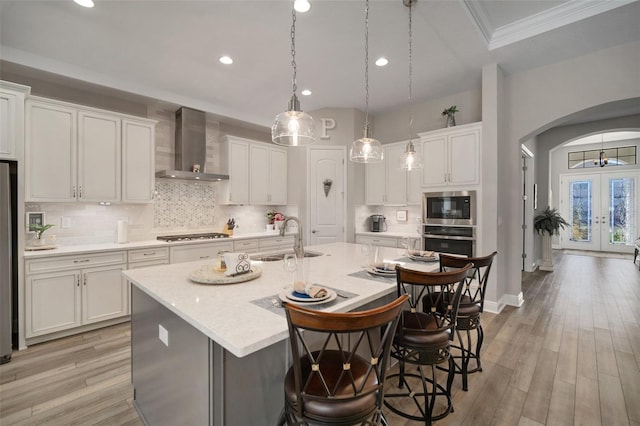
[0,161,18,364]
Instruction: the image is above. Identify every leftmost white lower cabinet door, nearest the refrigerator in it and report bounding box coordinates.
[25,270,81,338]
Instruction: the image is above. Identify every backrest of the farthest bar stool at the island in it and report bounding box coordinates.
[440,251,498,312]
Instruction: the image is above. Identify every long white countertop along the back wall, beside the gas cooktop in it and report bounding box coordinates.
[24,232,295,259]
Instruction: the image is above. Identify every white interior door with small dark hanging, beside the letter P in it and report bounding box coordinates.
[309,147,346,245]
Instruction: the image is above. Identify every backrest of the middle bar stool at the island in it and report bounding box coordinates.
[396,263,472,336]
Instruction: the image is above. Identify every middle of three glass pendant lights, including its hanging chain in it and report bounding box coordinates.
[349,0,384,163]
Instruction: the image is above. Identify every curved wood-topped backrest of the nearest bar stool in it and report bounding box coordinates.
[285,295,407,418]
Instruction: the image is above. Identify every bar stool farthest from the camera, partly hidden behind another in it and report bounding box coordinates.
[438,251,498,391]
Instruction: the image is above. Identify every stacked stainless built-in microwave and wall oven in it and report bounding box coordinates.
[422,191,476,256]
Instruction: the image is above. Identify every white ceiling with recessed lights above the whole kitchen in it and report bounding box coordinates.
[0,0,640,126]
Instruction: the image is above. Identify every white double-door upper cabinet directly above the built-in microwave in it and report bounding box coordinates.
[418,123,482,187]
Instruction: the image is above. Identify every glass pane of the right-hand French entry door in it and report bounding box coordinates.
[609,178,635,244]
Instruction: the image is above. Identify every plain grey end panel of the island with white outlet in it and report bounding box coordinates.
[131,285,210,426]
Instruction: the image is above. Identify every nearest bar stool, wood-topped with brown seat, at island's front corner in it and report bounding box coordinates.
[279,295,407,425]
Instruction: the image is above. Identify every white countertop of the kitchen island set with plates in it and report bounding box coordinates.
[123,243,438,357]
